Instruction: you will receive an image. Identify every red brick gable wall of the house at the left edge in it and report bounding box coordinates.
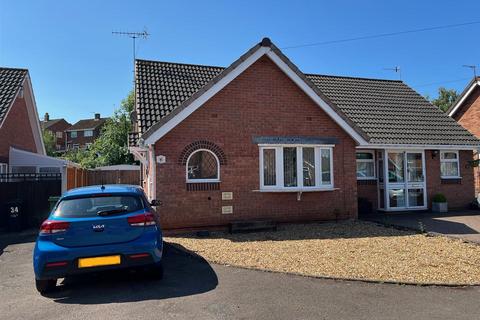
[0,98,37,163]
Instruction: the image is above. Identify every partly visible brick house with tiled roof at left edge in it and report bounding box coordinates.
[0,68,45,173]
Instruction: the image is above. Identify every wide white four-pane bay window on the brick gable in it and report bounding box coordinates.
[260,145,333,191]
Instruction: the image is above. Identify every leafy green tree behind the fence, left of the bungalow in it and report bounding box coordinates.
[62,91,135,168]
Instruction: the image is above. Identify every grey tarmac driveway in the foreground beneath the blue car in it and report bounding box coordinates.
[0,231,480,320]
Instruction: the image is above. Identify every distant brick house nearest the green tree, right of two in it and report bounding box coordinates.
[65,113,107,150]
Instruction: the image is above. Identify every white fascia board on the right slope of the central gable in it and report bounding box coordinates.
[267,51,368,145]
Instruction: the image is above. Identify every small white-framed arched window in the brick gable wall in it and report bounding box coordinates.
[187,149,220,182]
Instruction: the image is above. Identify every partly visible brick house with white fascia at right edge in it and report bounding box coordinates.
[447,77,480,194]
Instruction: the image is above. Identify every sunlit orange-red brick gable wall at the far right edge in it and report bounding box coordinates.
[453,86,480,138]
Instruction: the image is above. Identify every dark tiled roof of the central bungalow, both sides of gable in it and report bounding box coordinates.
[131,48,480,146]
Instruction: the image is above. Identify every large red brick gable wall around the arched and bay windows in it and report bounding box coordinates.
[155,57,357,229]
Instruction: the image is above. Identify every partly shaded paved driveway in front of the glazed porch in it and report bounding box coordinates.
[360,210,480,243]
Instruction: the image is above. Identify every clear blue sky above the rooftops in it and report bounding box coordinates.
[0,0,480,122]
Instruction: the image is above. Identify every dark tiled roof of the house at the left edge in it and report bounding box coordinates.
[0,68,28,124]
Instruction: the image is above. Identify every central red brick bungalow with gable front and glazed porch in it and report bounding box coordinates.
[129,38,480,229]
